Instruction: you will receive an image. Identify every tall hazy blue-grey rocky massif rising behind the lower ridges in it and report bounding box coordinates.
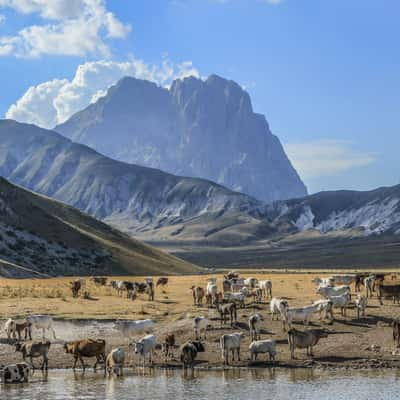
[55,75,307,201]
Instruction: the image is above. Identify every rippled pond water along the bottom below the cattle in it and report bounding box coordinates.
[0,369,400,400]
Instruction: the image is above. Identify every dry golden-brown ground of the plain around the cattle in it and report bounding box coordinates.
[0,271,400,368]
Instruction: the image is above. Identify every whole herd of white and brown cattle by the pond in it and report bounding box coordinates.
[0,272,400,383]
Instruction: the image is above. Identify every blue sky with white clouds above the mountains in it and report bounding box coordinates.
[0,0,400,192]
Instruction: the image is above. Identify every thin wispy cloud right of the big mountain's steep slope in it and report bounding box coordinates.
[284,139,376,179]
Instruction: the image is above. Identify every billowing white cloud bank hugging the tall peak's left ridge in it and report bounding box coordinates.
[6,58,199,128]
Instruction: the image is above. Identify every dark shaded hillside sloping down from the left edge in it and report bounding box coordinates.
[0,173,198,277]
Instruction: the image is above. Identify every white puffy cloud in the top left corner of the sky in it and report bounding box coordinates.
[0,0,130,57]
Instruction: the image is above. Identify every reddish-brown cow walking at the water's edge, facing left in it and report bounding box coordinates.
[64,339,106,371]
